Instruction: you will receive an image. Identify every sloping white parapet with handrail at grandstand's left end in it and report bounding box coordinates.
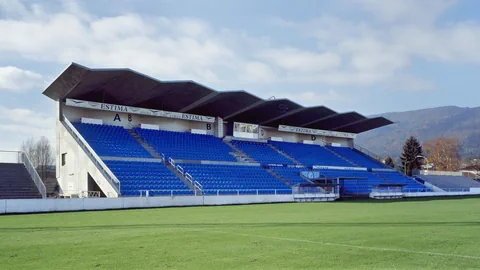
[61,116,121,195]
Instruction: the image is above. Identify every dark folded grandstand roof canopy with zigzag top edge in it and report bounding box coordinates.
[43,63,393,133]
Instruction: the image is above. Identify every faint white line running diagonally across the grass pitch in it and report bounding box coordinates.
[187,228,480,260]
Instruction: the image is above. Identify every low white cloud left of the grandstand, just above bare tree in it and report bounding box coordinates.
[0,106,55,150]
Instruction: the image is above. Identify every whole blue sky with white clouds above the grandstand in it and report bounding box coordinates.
[0,0,480,149]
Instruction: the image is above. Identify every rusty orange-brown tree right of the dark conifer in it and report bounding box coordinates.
[424,137,462,171]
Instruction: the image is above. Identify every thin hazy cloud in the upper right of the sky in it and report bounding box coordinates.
[273,0,480,91]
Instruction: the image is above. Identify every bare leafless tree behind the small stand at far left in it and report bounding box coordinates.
[20,137,55,179]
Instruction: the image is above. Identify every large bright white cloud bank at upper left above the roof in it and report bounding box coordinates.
[0,3,237,83]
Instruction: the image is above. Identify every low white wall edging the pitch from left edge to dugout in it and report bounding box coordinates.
[0,195,294,214]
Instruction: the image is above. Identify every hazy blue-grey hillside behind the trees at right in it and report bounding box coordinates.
[357,106,480,157]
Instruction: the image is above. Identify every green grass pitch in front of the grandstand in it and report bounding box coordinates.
[0,198,480,270]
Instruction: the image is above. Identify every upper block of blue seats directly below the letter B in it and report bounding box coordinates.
[135,128,237,162]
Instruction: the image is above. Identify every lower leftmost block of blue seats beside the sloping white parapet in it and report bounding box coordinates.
[105,160,194,196]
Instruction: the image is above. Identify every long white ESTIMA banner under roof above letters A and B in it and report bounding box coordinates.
[66,98,215,123]
